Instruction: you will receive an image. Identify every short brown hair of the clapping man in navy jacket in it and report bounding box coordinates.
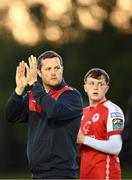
[37,50,63,69]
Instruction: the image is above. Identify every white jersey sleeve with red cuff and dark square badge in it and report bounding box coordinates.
[107,104,125,137]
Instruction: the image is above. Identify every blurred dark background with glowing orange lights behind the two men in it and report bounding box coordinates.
[0,0,132,179]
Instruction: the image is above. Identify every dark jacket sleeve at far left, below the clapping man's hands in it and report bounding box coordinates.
[5,92,28,122]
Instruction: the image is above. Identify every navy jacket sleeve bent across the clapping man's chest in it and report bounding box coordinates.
[32,84,82,120]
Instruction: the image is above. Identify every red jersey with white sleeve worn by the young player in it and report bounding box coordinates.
[80,100,124,179]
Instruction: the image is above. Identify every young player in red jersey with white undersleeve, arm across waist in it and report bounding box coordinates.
[77,68,124,179]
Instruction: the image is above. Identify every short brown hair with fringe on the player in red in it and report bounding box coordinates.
[84,68,110,84]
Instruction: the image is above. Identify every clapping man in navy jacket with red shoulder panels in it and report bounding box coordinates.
[6,51,82,179]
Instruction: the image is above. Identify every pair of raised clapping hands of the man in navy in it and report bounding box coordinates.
[15,55,37,95]
